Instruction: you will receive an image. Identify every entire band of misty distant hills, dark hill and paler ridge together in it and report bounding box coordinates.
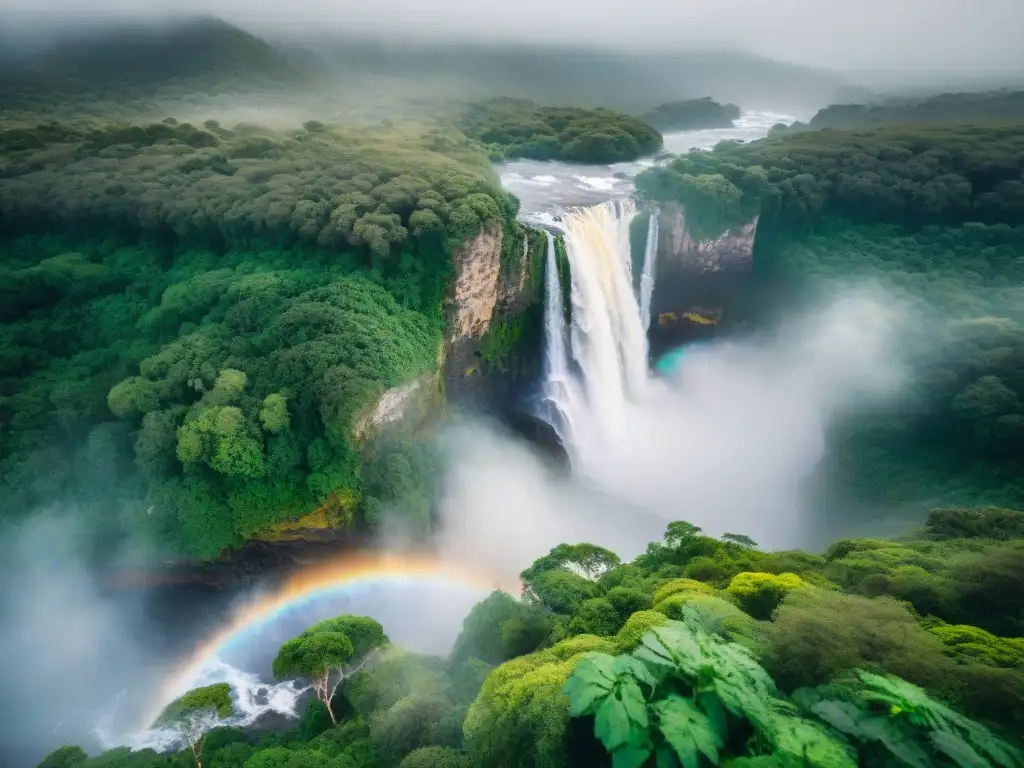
[0,8,844,127]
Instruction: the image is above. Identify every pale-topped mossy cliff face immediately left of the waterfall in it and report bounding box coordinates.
[442,223,545,413]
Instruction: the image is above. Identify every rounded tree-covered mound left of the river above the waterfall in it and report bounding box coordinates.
[458,98,662,163]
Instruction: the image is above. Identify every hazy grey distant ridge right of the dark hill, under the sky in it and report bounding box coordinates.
[293,36,844,112]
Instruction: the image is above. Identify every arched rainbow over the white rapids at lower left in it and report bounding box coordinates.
[143,553,512,728]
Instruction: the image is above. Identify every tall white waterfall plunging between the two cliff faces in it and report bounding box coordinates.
[545,200,653,471]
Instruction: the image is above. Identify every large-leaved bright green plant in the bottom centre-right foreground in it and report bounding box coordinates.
[563,606,856,768]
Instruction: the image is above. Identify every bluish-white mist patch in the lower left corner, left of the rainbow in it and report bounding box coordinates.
[0,510,176,766]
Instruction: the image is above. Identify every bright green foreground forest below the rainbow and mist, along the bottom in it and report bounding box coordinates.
[41,508,1024,768]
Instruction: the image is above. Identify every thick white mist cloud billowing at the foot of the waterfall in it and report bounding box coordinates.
[440,287,913,572]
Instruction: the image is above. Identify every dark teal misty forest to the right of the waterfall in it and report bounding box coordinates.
[637,123,1024,507]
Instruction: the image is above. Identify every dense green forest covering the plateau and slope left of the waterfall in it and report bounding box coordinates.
[0,115,524,557]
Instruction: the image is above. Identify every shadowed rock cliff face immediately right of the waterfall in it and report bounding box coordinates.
[650,203,758,355]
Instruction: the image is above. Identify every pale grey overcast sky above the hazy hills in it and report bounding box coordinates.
[0,0,1024,71]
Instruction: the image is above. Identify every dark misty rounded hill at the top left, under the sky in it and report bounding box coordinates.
[0,15,316,120]
